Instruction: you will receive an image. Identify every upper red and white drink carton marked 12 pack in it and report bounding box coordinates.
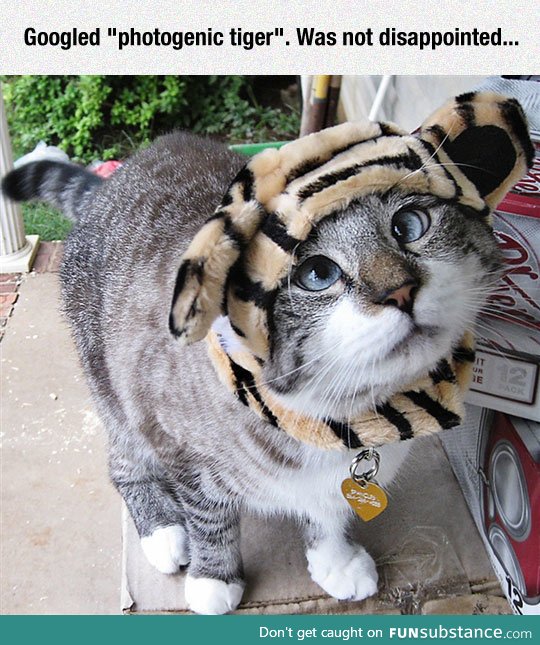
[467,132,540,421]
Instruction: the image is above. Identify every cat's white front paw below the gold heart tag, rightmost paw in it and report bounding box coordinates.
[306,545,379,600]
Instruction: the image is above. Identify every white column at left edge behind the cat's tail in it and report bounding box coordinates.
[0,85,39,273]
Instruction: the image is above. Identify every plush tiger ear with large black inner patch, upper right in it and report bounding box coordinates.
[419,92,534,211]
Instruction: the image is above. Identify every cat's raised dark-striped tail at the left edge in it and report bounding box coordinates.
[2,160,103,221]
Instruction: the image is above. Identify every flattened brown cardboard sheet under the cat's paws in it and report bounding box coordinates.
[122,430,496,614]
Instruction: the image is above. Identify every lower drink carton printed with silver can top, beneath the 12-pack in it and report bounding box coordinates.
[442,405,540,615]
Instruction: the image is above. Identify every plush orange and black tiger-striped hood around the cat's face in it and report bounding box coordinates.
[169,93,534,448]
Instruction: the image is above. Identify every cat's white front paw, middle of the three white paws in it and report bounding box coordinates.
[185,575,244,615]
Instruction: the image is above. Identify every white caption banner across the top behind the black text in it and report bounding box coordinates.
[0,0,540,75]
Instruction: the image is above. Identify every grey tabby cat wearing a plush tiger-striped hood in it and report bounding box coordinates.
[3,94,531,614]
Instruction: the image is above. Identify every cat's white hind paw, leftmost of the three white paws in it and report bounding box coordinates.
[141,524,189,573]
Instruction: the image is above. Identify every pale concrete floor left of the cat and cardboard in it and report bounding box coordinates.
[0,273,121,614]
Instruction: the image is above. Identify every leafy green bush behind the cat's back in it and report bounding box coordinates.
[0,76,299,163]
